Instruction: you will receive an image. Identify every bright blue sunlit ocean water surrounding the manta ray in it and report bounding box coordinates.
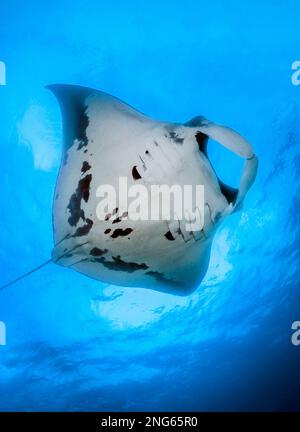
[0,0,300,411]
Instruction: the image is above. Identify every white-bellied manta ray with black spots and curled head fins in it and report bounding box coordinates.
[0,84,258,295]
